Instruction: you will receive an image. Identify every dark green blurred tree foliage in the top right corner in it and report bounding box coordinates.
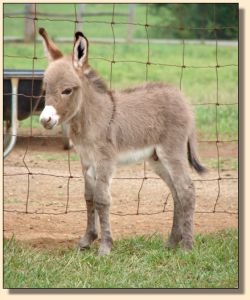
[149,3,238,40]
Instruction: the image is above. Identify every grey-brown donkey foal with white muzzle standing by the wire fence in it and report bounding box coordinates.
[39,28,204,255]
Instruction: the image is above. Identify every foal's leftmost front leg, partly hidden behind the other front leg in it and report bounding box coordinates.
[78,167,98,250]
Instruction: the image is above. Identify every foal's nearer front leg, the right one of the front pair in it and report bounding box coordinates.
[94,160,114,255]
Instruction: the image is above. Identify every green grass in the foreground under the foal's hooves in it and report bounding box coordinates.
[4,229,238,288]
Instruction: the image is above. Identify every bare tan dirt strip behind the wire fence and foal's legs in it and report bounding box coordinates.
[4,138,238,248]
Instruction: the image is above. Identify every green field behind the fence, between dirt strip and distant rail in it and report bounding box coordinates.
[5,40,238,140]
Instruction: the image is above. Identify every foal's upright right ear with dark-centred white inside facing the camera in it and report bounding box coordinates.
[73,31,89,69]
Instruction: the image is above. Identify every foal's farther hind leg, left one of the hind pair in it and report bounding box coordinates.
[149,158,183,248]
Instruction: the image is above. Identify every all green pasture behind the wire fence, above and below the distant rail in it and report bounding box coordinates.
[4,4,238,140]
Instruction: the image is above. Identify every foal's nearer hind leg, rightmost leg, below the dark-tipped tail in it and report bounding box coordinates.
[157,143,195,250]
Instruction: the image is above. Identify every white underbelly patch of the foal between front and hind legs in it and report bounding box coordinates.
[117,146,155,165]
